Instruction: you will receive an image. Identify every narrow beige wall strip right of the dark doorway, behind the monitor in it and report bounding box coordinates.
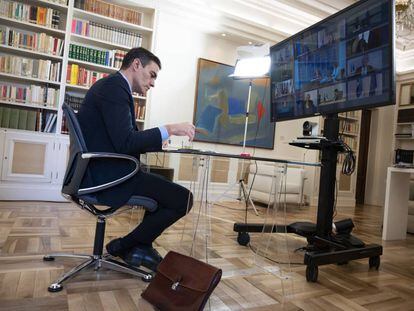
[365,106,395,206]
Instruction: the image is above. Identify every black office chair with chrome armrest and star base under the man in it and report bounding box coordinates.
[43,104,157,292]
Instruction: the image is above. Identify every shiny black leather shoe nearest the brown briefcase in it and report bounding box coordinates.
[121,246,162,272]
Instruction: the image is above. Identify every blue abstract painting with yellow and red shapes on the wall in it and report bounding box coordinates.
[193,58,275,149]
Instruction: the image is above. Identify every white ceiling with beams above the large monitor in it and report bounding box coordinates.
[156,0,414,70]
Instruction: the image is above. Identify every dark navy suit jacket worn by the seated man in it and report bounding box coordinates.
[78,72,162,207]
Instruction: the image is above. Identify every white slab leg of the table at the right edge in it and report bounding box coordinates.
[382,171,410,241]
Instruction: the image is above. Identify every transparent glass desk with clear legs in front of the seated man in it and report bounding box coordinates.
[142,149,320,304]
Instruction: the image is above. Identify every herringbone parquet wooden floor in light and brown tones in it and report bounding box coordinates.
[0,202,414,311]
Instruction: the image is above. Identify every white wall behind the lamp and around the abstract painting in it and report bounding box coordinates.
[146,9,318,202]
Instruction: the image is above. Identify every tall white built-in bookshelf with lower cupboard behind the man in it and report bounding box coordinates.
[0,0,156,201]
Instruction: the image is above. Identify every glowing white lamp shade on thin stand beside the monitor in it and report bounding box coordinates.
[230,56,270,79]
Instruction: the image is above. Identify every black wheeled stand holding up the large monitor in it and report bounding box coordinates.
[234,114,382,282]
